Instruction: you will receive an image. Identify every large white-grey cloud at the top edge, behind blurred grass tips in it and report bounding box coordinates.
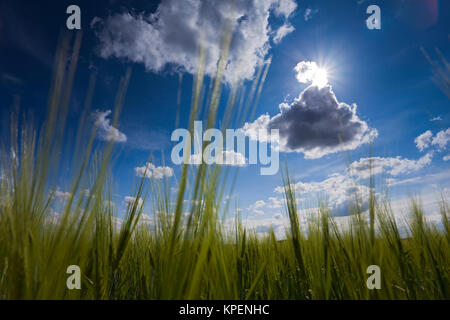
[91,0,297,82]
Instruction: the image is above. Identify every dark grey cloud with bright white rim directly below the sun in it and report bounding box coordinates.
[244,85,378,159]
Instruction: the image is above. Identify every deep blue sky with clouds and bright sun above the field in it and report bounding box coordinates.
[0,0,450,234]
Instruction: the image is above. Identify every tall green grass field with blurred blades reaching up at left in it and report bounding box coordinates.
[0,35,450,299]
